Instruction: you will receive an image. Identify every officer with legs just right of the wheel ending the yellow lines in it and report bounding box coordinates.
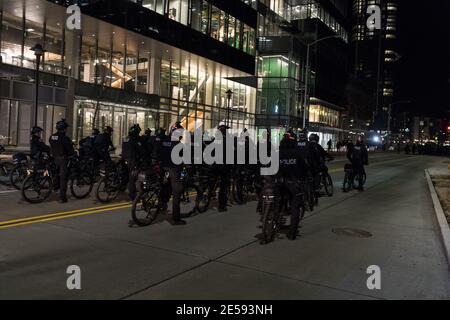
[158,122,186,226]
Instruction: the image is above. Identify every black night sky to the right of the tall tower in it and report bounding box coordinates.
[396,0,450,118]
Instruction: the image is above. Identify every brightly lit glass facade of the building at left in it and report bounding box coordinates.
[0,0,256,152]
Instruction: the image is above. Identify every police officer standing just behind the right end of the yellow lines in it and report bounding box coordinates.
[122,124,143,201]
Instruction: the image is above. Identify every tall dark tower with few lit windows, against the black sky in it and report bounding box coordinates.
[351,0,400,131]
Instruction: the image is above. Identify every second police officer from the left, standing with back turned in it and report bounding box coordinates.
[50,119,75,203]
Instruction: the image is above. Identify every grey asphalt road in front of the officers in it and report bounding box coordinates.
[0,154,450,299]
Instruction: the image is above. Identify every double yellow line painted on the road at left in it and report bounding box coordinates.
[0,202,131,229]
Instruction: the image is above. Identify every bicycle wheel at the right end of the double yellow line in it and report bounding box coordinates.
[131,191,161,227]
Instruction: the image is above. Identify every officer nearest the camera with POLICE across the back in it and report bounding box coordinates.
[277,131,308,240]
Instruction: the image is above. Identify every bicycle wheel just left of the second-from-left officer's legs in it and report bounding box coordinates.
[21,175,53,203]
